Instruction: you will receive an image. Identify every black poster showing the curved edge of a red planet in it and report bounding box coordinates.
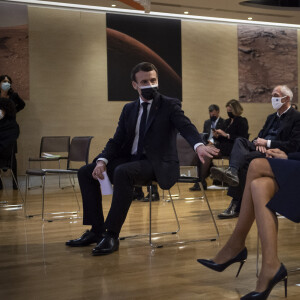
[106,14,182,101]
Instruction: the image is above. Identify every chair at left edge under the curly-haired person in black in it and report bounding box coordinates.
[0,142,24,207]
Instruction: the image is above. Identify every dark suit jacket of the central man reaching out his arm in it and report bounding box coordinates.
[94,94,203,189]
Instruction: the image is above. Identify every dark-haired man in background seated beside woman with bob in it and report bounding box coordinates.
[190,104,224,191]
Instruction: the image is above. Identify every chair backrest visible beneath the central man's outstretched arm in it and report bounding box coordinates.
[177,134,199,166]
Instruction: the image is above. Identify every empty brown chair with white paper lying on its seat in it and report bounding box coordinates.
[28,136,70,188]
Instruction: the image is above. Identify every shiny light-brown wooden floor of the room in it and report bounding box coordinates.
[0,178,300,300]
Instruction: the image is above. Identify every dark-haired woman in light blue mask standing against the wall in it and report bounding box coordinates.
[0,75,25,189]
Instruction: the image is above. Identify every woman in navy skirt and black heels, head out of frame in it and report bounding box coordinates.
[198,149,300,300]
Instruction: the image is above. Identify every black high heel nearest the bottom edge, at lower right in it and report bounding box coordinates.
[241,264,287,300]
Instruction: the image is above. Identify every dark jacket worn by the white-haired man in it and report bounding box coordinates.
[258,108,300,153]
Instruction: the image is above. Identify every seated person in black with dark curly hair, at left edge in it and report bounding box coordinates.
[0,98,20,190]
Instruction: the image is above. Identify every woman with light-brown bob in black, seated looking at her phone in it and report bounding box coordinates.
[191,99,249,191]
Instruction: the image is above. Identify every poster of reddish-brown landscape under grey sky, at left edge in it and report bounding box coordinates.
[0,3,29,100]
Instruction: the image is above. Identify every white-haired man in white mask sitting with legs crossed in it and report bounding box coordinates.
[211,85,300,219]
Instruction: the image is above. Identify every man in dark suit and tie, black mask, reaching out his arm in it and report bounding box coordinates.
[66,63,218,255]
